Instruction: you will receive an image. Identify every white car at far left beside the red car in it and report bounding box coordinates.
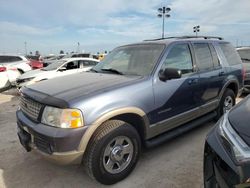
[0,55,31,74]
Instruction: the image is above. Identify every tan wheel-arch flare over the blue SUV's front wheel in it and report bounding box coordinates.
[78,107,149,153]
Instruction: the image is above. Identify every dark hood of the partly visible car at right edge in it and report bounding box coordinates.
[228,96,250,146]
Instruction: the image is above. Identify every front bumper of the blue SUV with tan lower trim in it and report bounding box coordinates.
[16,110,87,164]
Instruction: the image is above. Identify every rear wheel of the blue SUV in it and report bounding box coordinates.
[215,89,236,120]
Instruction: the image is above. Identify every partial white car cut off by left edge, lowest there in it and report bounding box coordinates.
[0,64,21,92]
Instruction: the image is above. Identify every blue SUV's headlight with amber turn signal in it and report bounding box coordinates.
[42,106,83,128]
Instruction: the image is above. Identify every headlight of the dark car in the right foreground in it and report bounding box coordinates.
[219,113,250,162]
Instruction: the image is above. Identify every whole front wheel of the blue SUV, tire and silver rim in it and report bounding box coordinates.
[84,120,141,185]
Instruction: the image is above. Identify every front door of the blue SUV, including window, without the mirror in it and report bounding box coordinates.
[151,43,200,135]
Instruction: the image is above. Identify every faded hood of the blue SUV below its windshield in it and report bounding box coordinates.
[22,72,142,106]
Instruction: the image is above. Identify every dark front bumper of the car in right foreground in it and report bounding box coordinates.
[204,124,250,188]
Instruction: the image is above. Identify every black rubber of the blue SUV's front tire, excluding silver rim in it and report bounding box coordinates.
[92,124,141,185]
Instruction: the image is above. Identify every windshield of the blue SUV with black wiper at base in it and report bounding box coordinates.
[93,44,165,76]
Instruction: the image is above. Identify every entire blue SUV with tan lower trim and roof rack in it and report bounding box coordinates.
[17,36,243,184]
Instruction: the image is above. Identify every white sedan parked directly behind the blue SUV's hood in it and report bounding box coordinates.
[16,58,99,88]
